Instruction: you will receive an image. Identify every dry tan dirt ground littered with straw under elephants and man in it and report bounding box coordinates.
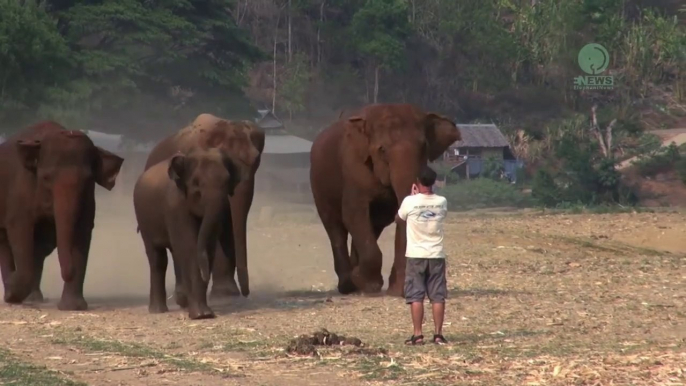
[0,173,686,386]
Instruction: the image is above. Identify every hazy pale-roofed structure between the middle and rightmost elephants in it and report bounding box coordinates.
[255,110,312,198]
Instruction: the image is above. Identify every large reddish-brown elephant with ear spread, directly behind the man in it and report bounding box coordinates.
[310,104,461,296]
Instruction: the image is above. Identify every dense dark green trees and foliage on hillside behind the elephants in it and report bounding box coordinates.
[0,0,686,205]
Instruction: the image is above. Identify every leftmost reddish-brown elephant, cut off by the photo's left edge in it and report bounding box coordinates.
[0,121,124,311]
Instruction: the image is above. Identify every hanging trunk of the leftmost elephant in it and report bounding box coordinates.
[53,177,83,282]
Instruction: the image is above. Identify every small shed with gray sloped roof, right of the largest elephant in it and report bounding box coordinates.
[443,123,522,180]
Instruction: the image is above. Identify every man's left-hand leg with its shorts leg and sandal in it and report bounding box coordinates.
[405,258,428,344]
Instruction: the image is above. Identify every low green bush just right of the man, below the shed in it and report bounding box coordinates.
[439,178,534,210]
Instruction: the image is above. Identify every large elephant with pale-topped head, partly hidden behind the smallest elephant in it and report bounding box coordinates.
[145,114,265,306]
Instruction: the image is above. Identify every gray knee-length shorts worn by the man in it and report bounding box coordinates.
[405,257,448,304]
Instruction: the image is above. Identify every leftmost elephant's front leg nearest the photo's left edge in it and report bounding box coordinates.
[5,216,35,304]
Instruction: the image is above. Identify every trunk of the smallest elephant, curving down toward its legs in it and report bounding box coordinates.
[197,195,226,283]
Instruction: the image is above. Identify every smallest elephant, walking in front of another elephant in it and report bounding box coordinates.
[133,149,238,319]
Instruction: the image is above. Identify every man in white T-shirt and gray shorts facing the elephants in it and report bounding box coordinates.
[396,166,448,345]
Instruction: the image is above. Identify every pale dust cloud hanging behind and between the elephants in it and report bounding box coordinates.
[21,154,395,307]
